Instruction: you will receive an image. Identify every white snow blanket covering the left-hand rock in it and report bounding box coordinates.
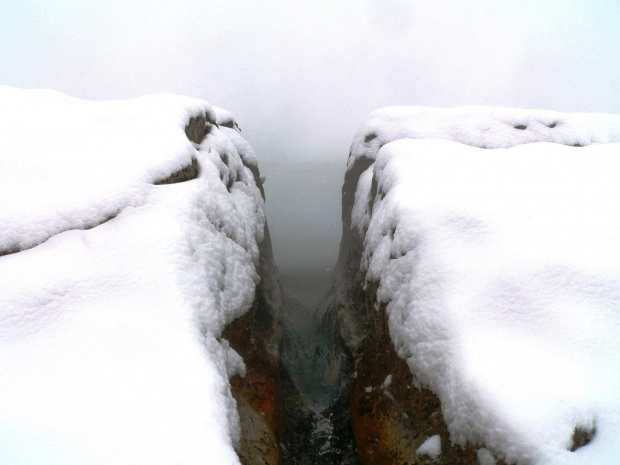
[0,87,265,465]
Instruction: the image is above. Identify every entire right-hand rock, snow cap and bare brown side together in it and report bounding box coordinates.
[336,107,620,465]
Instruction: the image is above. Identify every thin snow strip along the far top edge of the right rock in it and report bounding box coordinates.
[348,106,620,168]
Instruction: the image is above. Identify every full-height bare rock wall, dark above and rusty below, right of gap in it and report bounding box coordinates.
[336,157,478,465]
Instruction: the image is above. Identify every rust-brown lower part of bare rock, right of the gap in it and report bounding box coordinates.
[350,293,501,465]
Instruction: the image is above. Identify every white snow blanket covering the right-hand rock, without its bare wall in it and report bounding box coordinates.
[352,109,620,465]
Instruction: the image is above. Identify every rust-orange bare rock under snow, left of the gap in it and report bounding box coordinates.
[222,294,286,465]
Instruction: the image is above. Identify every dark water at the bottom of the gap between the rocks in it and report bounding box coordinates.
[281,290,358,465]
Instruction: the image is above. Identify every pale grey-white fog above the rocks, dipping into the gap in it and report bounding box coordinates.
[0,0,620,308]
